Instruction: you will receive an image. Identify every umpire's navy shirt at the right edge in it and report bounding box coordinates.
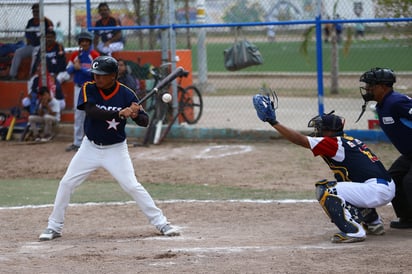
[376,91,412,156]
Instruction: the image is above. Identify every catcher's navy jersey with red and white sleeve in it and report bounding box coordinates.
[308,135,391,182]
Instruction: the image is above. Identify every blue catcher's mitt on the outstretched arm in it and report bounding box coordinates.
[253,88,278,126]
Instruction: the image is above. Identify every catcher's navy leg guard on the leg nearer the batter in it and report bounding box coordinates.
[316,180,364,234]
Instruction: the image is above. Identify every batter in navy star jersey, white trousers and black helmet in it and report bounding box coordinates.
[39,56,180,240]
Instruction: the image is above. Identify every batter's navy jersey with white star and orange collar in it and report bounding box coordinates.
[77,82,138,145]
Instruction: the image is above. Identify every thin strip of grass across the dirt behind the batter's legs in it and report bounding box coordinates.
[0,179,314,207]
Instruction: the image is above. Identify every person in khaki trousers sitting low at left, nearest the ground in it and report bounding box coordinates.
[29,87,60,142]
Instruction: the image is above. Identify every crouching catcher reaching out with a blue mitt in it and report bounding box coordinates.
[253,93,395,243]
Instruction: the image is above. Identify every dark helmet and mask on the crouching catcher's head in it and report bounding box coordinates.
[308,110,345,137]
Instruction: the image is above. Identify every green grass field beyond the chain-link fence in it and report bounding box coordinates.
[192,39,412,72]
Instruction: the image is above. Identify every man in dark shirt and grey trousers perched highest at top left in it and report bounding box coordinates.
[9,4,53,80]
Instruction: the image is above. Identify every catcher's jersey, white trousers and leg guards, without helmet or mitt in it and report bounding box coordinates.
[308,135,395,241]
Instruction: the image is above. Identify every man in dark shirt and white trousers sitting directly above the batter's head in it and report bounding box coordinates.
[93,2,124,56]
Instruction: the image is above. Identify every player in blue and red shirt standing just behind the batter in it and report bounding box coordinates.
[66,32,99,151]
